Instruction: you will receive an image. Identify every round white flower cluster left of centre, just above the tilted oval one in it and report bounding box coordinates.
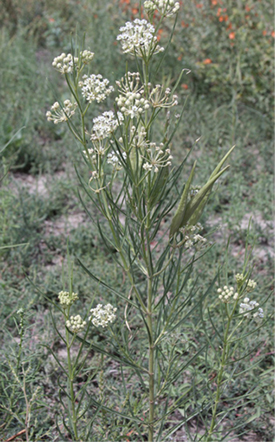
[78,74,114,103]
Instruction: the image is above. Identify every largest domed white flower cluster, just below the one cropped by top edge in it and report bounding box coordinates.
[117,18,164,59]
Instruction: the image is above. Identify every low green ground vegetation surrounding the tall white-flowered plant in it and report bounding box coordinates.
[0,0,274,442]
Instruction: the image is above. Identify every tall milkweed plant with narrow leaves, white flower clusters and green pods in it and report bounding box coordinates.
[46,0,268,442]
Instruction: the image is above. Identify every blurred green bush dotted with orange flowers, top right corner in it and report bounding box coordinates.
[174,0,275,112]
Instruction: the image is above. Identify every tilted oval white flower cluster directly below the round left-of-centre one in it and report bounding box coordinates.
[91,111,123,141]
